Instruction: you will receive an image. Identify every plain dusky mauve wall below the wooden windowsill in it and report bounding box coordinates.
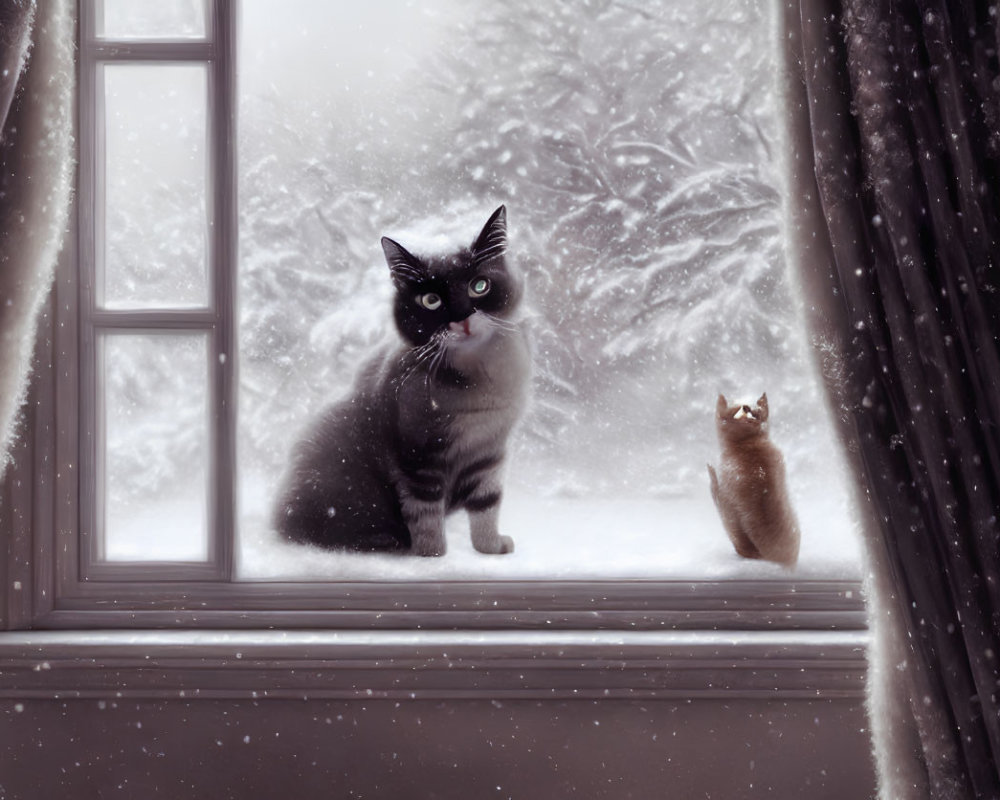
[0,698,875,800]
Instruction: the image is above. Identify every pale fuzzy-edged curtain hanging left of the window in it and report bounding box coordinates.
[0,0,75,473]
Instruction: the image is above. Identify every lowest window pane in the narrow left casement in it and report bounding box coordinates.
[100,334,209,561]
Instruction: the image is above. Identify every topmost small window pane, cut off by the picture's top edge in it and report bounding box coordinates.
[97,0,205,39]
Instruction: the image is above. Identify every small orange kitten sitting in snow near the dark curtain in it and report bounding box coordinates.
[708,394,799,567]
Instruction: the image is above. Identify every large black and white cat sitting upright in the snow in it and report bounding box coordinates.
[274,206,530,556]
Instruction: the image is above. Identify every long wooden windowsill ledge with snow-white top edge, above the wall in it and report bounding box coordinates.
[0,630,868,700]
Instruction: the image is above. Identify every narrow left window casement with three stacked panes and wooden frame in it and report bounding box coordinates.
[78,2,235,581]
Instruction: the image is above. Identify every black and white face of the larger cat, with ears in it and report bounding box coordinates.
[382,206,521,347]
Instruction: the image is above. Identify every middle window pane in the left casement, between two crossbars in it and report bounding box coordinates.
[98,64,209,308]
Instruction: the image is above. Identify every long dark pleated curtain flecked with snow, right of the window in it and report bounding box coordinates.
[782,0,1000,798]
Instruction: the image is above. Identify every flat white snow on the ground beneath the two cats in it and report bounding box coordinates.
[237,487,861,581]
